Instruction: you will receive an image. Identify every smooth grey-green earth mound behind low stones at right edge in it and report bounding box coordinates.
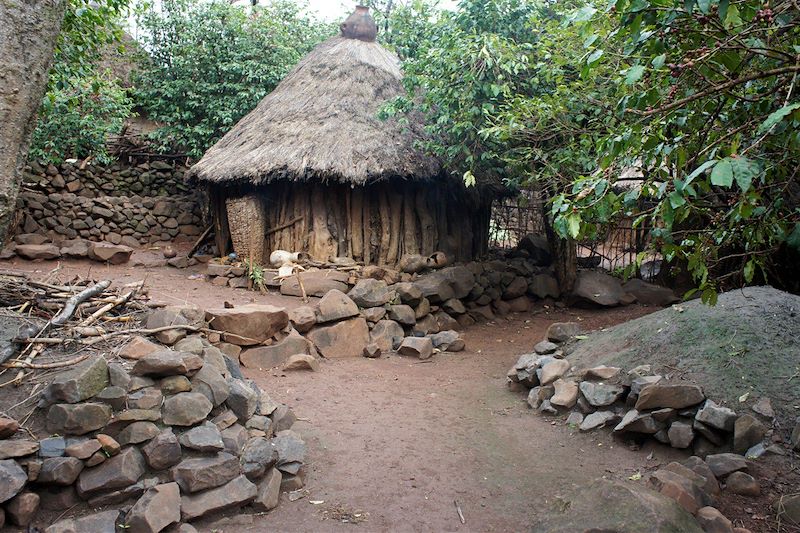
[569,287,800,427]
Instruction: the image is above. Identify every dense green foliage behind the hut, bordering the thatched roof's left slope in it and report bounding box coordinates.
[136,0,334,157]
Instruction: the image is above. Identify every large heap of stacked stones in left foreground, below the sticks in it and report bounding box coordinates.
[0,330,306,533]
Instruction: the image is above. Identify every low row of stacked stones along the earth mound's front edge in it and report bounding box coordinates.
[508,322,779,457]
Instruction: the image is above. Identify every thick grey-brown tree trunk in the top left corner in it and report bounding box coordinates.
[0,0,66,239]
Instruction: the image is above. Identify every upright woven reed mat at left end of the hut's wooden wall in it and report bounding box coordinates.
[225,194,267,265]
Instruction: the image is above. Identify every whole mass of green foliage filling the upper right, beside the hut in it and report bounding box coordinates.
[396,0,800,296]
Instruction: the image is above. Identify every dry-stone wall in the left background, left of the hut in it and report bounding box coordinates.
[16,161,203,244]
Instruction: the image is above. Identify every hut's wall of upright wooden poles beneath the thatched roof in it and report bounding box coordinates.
[212,182,490,266]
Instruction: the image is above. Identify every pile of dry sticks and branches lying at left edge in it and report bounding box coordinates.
[0,274,148,385]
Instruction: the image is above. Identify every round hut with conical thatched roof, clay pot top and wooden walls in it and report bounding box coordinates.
[189,6,488,264]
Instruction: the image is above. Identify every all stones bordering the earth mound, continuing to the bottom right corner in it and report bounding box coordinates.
[507,322,800,533]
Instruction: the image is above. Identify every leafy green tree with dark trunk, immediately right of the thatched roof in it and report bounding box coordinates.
[386,0,615,290]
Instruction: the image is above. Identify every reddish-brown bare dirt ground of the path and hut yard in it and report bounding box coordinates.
[0,261,792,532]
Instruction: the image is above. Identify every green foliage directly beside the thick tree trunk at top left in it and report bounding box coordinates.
[29,0,132,163]
